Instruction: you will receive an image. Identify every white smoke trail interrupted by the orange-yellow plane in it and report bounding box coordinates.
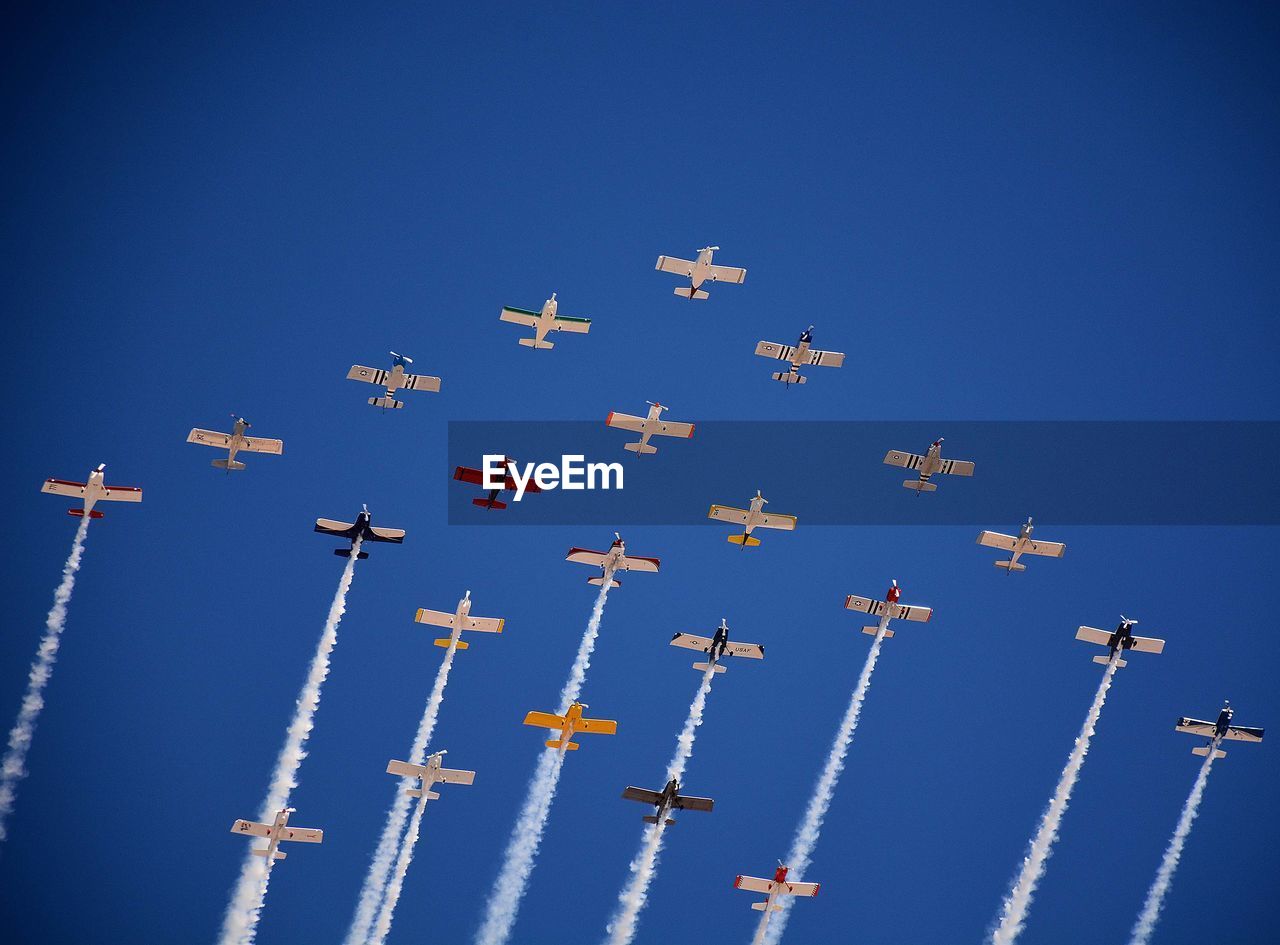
[476,570,613,945]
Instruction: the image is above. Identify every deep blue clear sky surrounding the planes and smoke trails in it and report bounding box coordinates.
[0,4,1280,945]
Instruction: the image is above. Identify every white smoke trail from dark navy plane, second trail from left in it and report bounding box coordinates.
[219,538,361,945]
